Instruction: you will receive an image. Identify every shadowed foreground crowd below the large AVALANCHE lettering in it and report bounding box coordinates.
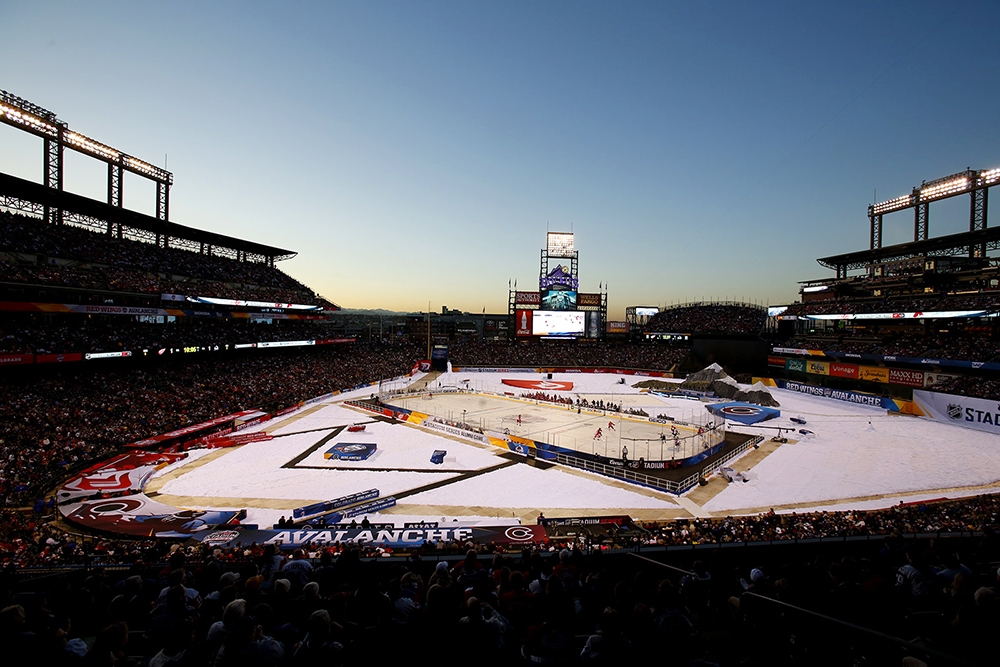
[0,496,1000,665]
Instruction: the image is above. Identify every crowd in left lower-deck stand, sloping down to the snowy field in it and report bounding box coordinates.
[0,344,420,506]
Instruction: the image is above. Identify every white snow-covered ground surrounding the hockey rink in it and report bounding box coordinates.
[150,372,1000,523]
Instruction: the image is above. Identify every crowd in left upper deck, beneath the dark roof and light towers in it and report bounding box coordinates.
[0,211,331,306]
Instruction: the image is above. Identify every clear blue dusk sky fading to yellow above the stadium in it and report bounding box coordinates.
[0,0,1000,317]
